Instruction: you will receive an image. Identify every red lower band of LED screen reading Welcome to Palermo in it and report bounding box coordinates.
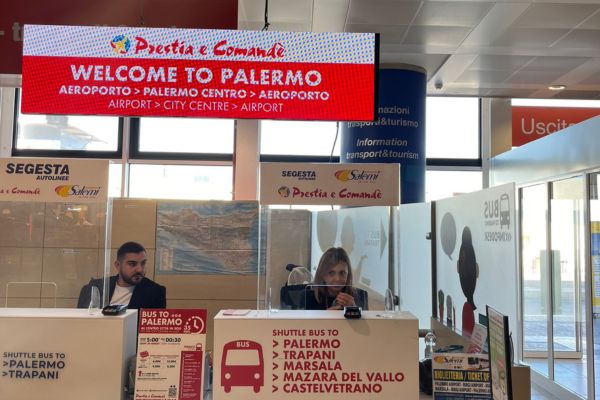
[21,56,375,121]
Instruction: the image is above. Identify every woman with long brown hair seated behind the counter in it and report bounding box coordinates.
[305,247,356,310]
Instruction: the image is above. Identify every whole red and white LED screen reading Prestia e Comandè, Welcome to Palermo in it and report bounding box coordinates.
[21,25,377,121]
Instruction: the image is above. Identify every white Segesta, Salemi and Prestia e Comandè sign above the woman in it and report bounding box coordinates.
[260,163,400,206]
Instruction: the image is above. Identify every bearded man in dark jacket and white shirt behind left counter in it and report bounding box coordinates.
[77,242,167,309]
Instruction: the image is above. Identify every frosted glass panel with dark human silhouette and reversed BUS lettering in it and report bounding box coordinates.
[435,184,518,350]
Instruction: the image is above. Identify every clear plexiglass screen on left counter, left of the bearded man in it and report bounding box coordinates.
[0,201,110,312]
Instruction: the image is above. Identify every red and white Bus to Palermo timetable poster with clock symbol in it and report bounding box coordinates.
[134,309,207,400]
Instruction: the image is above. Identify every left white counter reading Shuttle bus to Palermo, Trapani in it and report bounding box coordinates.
[0,308,137,400]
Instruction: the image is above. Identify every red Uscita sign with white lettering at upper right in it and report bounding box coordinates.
[512,107,600,146]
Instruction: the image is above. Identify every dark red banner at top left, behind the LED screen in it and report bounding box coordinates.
[0,0,238,74]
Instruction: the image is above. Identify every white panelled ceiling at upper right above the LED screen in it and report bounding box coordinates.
[238,0,600,99]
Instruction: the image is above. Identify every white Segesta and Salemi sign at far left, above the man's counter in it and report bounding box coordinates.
[0,158,109,203]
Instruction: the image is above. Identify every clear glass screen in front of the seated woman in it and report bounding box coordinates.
[260,206,393,310]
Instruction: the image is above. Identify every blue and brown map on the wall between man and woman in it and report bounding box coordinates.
[156,201,259,275]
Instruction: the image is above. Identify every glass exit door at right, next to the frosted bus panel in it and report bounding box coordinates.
[520,176,588,397]
